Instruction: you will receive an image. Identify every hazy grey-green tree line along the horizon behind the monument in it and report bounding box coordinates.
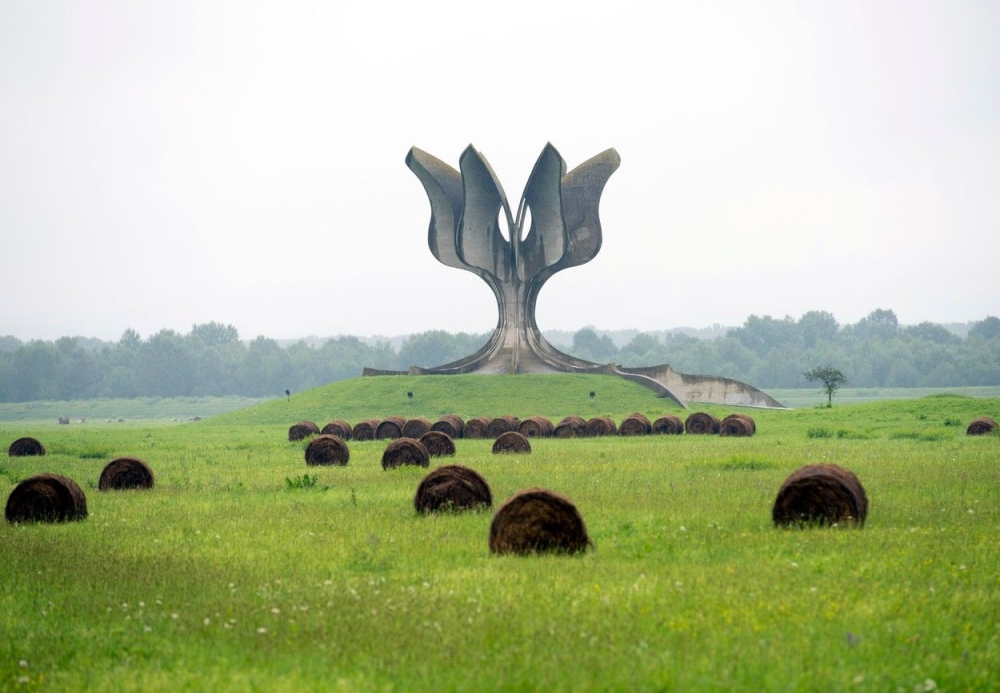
[0,309,1000,402]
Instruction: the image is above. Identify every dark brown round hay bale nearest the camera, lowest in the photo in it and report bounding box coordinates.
[490,488,593,556]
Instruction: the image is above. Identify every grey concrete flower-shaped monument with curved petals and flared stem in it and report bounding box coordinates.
[406,144,621,373]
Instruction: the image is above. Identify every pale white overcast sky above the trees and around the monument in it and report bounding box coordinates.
[0,0,1000,339]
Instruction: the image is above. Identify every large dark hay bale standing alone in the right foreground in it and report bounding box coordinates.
[771,464,868,526]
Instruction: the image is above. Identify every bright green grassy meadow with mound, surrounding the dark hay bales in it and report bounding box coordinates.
[0,375,1000,693]
